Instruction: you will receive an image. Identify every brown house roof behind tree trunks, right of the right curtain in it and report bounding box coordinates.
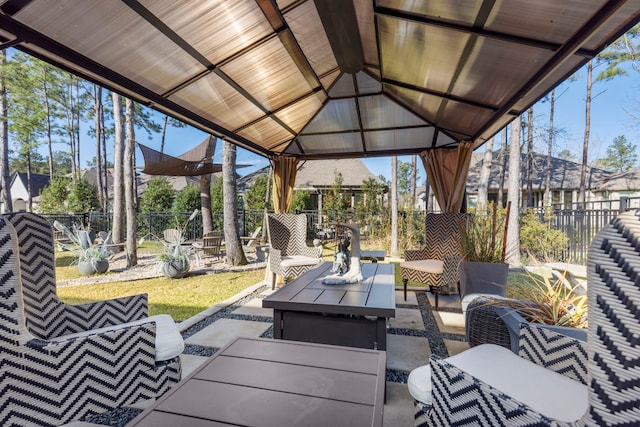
[467,151,612,193]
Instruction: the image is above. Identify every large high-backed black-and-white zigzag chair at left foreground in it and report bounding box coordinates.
[0,213,184,426]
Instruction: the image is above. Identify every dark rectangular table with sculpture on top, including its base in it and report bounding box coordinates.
[262,262,396,350]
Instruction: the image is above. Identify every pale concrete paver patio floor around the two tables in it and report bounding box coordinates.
[66,283,468,427]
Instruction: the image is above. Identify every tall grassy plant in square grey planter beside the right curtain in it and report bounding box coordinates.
[459,203,509,298]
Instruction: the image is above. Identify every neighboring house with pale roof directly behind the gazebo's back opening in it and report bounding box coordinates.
[238,159,388,210]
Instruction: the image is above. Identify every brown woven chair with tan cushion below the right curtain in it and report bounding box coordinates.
[400,213,469,310]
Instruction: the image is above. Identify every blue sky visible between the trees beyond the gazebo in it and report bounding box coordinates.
[66,59,640,182]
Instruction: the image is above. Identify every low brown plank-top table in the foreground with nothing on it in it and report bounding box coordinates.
[128,338,386,427]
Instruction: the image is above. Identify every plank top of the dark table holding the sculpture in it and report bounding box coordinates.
[262,262,396,317]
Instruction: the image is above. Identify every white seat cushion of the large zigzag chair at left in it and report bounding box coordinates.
[56,314,184,361]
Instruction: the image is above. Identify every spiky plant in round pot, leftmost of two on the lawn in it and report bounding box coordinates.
[53,221,112,276]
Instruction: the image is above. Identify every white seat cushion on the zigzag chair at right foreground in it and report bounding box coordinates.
[445,344,589,422]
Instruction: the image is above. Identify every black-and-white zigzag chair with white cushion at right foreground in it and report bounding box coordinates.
[407,210,640,426]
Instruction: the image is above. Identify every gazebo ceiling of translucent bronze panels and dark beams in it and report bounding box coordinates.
[0,0,640,159]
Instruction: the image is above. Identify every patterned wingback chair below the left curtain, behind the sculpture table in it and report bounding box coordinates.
[267,214,322,289]
